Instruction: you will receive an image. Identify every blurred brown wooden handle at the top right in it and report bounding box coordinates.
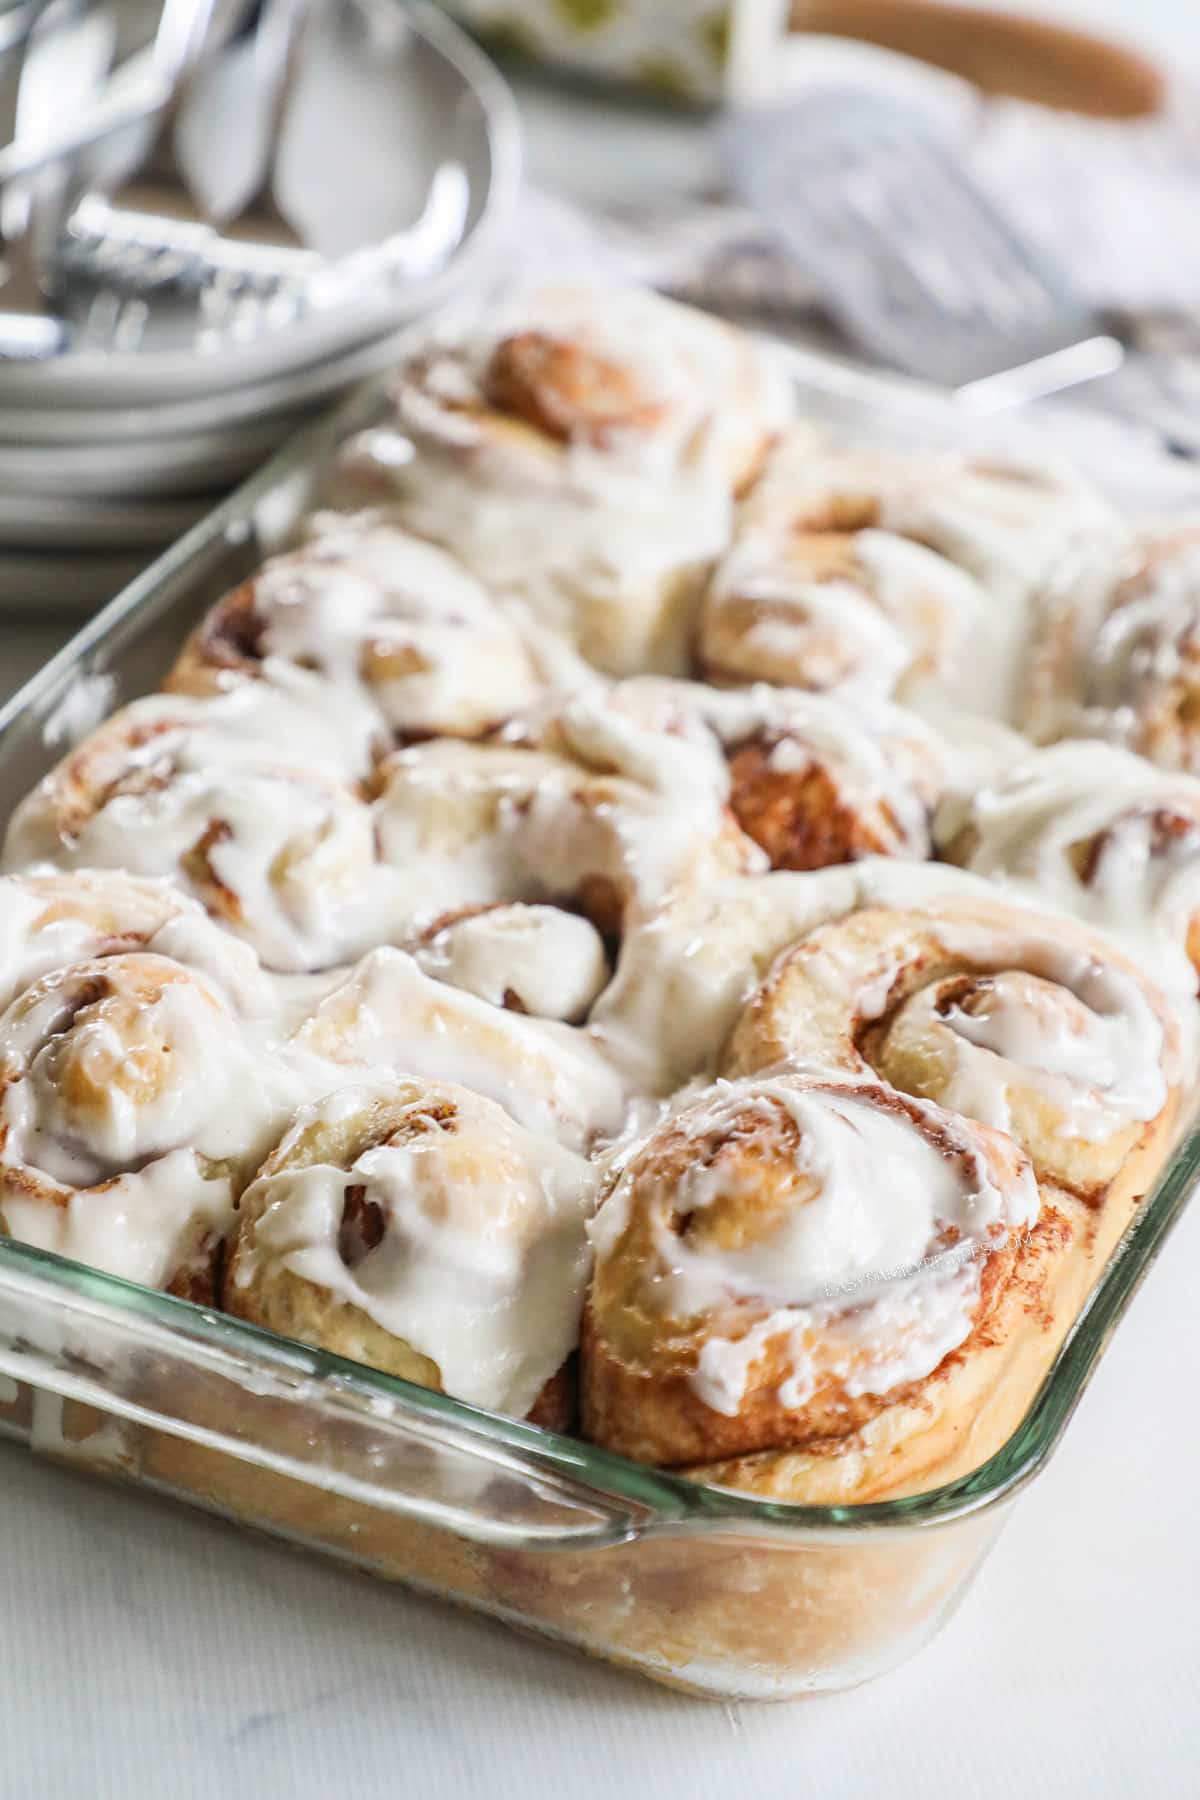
[790,0,1164,119]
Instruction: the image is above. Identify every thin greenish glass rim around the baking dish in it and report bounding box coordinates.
[0,354,1200,1548]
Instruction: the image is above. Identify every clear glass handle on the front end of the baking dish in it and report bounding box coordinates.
[0,1244,682,1550]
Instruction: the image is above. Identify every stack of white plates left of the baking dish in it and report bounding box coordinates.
[0,0,518,612]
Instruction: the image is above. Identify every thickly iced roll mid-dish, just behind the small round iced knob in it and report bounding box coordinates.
[376,691,763,936]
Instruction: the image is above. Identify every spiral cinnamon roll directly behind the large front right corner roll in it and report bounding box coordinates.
[723,896,1184,1206]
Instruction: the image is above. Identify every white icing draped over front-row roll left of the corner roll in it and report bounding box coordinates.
[239,1087,597,1417]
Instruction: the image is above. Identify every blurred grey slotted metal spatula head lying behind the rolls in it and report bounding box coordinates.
[725,90,1123,410]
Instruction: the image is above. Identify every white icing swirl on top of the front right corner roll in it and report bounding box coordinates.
[592,1080,1038,1417]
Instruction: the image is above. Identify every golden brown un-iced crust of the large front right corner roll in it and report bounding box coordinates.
[581,1076,1027,1465]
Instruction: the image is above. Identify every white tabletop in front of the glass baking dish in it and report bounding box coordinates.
[0,0,1200,1800]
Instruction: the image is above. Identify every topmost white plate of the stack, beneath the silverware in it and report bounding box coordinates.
[0,0,520,412]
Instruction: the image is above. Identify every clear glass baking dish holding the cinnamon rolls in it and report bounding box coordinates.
[0,355,1200,1699]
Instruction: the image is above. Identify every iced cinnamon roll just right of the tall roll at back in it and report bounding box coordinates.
[696,437,1106,716]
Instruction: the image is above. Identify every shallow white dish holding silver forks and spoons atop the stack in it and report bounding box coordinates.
[0,0,520,406]
